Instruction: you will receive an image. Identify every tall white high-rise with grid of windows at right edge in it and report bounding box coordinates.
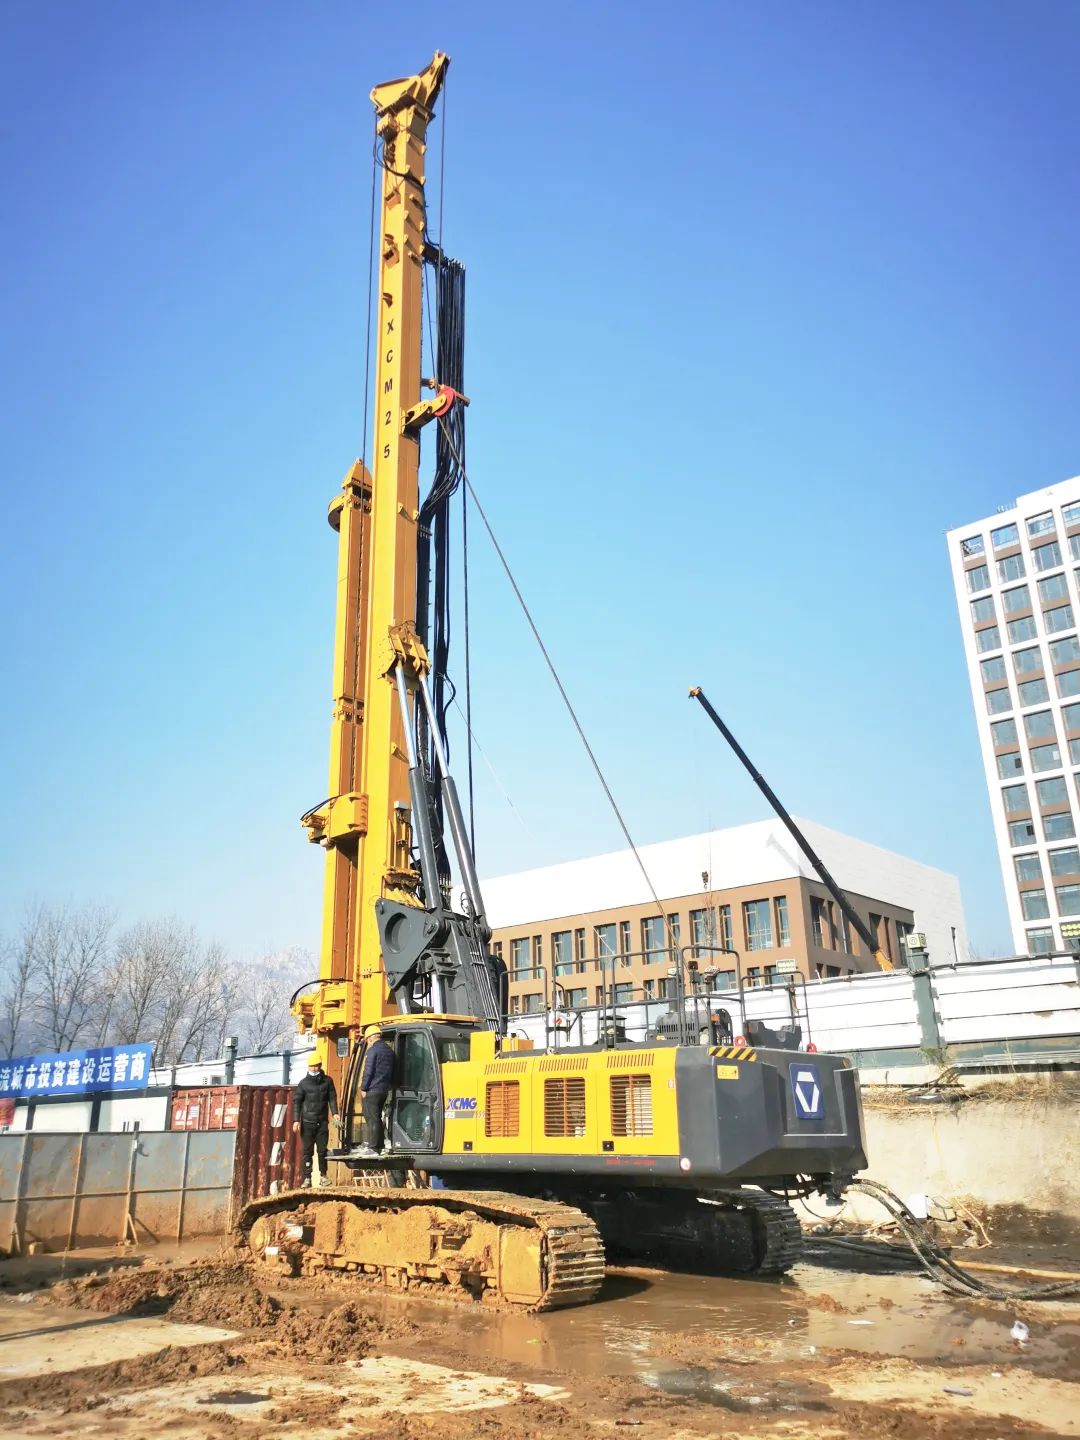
[948,475,1080,955]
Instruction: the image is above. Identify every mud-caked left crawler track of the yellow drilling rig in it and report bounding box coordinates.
[235,1187,605,1312]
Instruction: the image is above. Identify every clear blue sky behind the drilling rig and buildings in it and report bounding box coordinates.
[0,0,1080,958]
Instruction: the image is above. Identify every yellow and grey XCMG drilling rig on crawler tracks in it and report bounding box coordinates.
[238,53,865,1310]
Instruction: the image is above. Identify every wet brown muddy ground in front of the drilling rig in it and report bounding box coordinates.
[0,1244,1080,1440]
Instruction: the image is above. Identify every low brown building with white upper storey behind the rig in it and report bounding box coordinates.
[482,819,968,1014]
